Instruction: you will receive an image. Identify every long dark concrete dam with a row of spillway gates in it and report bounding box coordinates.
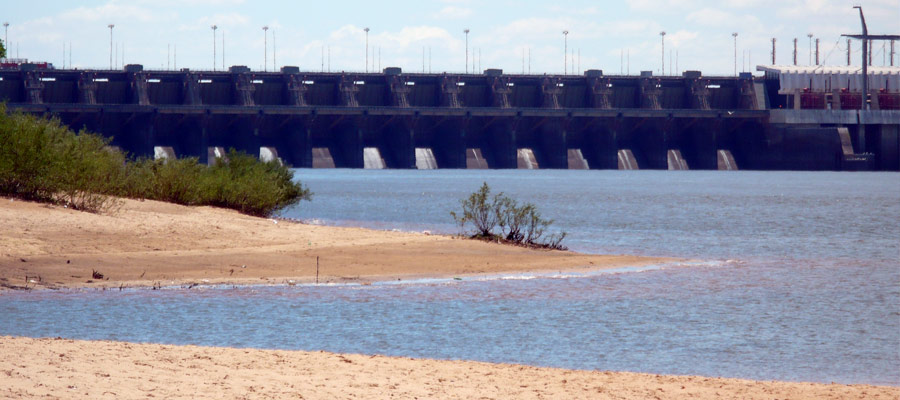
[0,64,900,171]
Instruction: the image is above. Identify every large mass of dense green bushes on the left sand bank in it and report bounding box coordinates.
[0,104,311,216]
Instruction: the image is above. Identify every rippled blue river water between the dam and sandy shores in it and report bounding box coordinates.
[0,170,900,385]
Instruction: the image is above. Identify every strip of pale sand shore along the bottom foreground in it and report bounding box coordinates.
[0,337,900,399]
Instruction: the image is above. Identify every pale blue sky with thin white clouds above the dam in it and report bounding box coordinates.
[0,0,900,75]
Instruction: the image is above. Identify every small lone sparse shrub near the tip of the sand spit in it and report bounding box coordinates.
[450,182,566,250]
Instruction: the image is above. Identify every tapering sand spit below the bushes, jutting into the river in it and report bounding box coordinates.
[0,197,673,290]
